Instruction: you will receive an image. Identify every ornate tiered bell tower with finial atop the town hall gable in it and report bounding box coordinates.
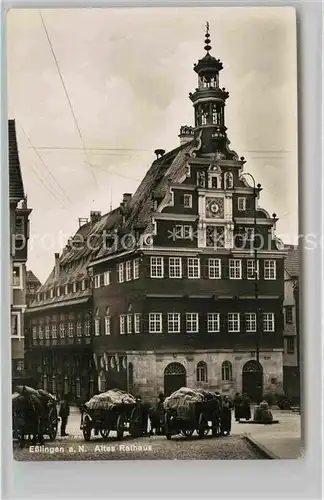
[189,23,235,158]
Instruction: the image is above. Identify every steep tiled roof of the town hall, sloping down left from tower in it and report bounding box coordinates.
[31,142,192,308]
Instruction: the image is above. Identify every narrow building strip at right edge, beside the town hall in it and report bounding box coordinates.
[283,245,300,400]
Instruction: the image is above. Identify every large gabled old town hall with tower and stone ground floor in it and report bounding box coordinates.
[30,26,285,399]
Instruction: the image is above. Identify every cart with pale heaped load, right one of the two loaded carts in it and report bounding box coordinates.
[164,387,221,439]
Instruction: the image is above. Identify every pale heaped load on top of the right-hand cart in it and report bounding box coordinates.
[164,387,217,419]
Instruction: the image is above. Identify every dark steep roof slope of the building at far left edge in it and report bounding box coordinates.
[8,120,24,201]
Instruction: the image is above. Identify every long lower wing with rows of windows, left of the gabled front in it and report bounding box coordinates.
[26,212,101,401]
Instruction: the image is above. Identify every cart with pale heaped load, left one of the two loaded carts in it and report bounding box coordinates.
[80,389,143,441]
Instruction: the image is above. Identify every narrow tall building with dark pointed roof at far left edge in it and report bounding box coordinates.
[8,120,31,385]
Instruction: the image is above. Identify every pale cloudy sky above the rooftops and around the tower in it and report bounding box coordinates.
[7,7,298,281]
